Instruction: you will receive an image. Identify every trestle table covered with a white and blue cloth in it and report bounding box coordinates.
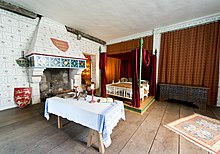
[44,96,125,153]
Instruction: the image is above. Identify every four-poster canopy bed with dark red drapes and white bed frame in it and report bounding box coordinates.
[101,36,156,108]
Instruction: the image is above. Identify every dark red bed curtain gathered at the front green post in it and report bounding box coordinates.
[131,49,140,108]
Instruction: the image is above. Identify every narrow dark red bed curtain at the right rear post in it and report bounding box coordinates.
[150,55,157,96]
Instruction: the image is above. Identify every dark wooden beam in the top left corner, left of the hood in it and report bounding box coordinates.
[0,0,38,19]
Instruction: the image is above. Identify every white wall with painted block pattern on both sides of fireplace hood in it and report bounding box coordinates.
[0,9,105,110]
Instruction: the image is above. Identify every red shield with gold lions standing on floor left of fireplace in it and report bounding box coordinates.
[14,88,32,108]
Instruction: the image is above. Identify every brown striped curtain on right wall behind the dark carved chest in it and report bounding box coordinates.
[158,21,220,105]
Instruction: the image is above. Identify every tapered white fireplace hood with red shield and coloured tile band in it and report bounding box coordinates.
[25,17,86,69]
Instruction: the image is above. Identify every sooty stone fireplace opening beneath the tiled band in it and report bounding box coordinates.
[40,68,71,102]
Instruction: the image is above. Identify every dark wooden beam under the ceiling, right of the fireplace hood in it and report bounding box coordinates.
[66,26,106,45]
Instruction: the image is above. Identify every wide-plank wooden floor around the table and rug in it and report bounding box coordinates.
[0,101,220,154]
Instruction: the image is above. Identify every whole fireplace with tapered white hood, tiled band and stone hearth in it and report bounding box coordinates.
[25,17,86,104]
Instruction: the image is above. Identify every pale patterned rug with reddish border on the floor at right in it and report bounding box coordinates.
[164,113,220,154]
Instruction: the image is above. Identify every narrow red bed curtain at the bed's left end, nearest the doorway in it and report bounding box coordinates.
[99,53,106,97]
